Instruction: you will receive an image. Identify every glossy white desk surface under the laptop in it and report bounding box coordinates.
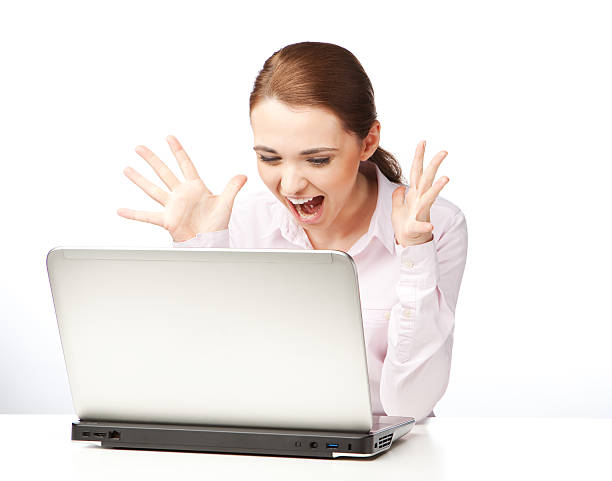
[0,414,612,481]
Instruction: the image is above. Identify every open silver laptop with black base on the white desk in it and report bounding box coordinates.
[47,247,415,458]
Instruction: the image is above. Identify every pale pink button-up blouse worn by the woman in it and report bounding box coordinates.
[173,161,468,421]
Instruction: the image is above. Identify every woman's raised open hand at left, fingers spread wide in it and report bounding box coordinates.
[117,135,247,242]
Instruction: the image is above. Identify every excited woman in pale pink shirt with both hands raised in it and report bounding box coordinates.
[118,42,467,420]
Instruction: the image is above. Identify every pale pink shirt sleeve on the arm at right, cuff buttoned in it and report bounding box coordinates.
[380,210,468,421]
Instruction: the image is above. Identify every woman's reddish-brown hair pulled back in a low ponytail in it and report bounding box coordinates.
[249,42,403,183]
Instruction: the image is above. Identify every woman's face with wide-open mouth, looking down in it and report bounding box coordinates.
[251,99,376,230]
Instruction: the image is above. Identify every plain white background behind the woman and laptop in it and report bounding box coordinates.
[0,0,612,417]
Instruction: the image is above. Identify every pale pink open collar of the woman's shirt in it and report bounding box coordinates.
[271,161,401,256]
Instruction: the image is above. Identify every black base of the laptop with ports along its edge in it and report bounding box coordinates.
[72,416,414,458]
